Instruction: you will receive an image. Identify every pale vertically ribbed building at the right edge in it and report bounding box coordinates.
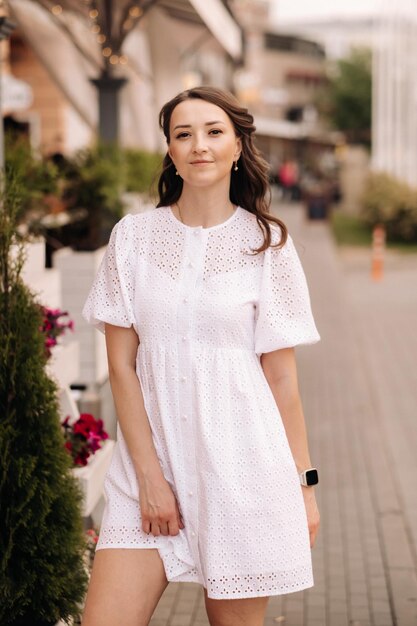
[372,0,417,187]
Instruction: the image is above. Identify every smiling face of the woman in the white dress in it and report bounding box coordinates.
[168,99,241,187]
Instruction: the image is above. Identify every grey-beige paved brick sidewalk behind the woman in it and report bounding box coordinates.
[151,206,417,626]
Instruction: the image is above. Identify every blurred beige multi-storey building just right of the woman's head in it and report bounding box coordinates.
[232,0,334,170]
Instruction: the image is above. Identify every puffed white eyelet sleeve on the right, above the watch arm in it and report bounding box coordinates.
[255,236,320,355]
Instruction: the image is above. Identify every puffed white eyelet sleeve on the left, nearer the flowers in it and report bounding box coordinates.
[82,215,135,332]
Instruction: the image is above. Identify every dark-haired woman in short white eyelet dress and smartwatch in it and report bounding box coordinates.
[83,87,319,626]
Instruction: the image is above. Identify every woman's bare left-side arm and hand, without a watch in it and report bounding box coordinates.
[106,324,184,536]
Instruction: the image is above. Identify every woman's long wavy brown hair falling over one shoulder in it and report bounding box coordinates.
[157,86,288,253]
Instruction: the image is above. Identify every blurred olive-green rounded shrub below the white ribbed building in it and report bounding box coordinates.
[361,173,417,242]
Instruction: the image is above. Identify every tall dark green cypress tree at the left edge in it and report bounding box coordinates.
[0,173,87,626]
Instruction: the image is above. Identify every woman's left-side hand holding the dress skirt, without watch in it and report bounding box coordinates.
[139,473,184,537]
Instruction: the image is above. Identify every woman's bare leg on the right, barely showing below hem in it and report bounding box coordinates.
[204,590,269,626]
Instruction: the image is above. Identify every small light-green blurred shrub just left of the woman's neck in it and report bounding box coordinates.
[124,148,163,195]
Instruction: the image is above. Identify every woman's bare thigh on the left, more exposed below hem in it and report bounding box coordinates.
[82,548,168,626]
